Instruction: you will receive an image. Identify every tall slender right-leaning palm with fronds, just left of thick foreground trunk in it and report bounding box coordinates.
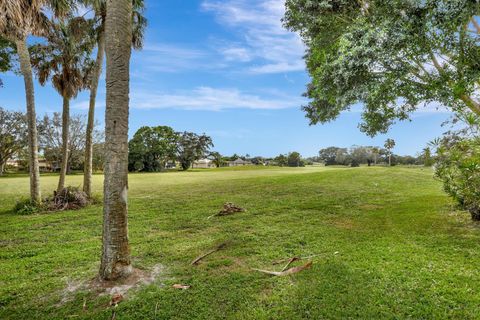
[82,0,147,197]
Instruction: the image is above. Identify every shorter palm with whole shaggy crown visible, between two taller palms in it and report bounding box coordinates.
[31,18,94,192]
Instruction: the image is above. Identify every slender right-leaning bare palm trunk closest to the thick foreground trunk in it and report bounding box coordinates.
[83,31,105,198]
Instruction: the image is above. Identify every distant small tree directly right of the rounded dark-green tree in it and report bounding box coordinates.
[177,131,213,170]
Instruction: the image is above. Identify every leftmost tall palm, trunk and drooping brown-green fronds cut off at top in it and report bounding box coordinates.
[0,0,72,203]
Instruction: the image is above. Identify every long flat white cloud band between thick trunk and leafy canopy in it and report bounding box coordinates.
[131,87,303,111]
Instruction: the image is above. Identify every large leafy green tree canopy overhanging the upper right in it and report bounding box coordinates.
[284,0,480,135]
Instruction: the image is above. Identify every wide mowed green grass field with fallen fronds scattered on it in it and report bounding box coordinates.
[0,167,480,319]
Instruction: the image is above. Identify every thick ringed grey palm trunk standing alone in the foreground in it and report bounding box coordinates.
[100,0,132,280]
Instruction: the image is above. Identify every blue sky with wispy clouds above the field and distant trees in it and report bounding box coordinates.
[0,0,449,156]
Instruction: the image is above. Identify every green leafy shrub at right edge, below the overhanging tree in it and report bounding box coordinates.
[435,136,480,220]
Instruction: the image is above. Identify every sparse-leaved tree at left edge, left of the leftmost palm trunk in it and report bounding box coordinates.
[0,108,28,175]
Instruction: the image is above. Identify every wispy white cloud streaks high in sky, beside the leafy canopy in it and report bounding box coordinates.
[202,0,305,74]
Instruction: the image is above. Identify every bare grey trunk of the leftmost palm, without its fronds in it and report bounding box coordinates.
[15,38,42,203]
